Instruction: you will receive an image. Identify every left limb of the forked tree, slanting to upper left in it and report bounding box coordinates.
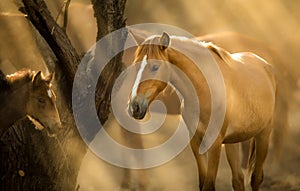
[22,0,80,87]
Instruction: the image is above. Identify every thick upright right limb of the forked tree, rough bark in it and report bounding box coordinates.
[91,0,127,124]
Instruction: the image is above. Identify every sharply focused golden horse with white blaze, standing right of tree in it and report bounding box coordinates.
[129,33,276,190]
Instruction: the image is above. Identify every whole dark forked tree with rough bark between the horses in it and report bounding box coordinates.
[0,0,126,191]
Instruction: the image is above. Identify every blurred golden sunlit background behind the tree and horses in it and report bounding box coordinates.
[0,0,300,190]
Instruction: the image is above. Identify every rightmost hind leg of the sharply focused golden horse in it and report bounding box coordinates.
[251,127,271,191]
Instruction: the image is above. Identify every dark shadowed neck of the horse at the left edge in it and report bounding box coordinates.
[0,84,28,136]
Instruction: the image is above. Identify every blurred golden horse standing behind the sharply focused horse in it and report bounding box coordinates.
[123,29,288,168]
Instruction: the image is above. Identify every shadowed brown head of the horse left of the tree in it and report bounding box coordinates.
[26,71,61,129]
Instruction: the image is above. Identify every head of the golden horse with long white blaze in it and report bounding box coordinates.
[129,33,171,119]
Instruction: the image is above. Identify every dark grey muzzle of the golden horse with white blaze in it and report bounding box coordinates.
[129,96,148,119]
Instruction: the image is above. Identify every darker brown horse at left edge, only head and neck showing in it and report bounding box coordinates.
[0,70,61,137]
